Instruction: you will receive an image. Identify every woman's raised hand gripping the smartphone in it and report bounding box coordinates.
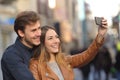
[98,18,108,36]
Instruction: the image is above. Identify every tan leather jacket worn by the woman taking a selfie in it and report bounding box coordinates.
[30,35,104,80]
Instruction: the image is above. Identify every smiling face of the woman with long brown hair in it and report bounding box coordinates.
[45,29,60,53]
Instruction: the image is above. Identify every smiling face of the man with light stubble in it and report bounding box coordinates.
[21,21,41,48]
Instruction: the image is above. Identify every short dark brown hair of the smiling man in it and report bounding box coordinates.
[14,11,40,36]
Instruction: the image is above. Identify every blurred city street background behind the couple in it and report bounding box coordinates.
[0,0,120,80]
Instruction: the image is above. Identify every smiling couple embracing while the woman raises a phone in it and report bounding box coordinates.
[1,11,108,80]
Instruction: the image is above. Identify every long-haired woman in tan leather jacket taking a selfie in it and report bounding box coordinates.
[30,19,107,80]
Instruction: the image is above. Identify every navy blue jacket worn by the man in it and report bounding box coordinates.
[1,38,35,80]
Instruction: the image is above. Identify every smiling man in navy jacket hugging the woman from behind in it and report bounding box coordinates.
[1,11,41,80]
